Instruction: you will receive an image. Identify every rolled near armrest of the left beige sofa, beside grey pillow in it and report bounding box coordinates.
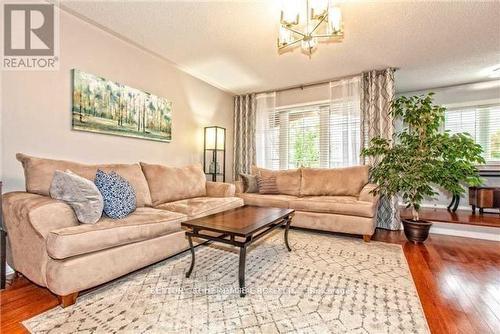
[2,192,78,286]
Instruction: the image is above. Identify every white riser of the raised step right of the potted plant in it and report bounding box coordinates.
[430,222,500,242]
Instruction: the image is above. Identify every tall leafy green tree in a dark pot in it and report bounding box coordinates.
[362,93,485,243]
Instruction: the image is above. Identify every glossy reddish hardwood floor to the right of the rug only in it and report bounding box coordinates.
[374,230,500,333]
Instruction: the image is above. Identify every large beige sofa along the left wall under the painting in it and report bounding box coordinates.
[3,154,243,306]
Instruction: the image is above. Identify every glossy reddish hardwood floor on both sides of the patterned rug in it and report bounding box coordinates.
[0,230,500,334]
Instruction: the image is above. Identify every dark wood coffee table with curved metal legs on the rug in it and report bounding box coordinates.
[182,205,294,297]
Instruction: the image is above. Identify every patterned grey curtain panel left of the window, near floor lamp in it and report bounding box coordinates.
[233,94,256,180]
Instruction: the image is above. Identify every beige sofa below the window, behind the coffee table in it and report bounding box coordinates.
[236,166,378,241]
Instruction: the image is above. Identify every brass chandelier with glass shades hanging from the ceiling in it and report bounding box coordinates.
[278,0,344,57]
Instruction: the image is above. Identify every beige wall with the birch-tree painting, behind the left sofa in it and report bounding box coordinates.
[0,11,233,191]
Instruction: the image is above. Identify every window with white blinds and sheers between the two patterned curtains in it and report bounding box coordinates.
[256,78,360,170]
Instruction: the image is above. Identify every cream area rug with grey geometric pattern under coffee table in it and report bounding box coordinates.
[23,230,429,333]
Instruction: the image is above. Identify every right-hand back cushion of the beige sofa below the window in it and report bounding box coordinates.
[300,166,369,196]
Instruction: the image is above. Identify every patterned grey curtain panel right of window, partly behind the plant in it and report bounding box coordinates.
[361,68,401,230]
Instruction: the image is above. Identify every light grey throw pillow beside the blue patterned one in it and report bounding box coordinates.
[50,170,104,224]
